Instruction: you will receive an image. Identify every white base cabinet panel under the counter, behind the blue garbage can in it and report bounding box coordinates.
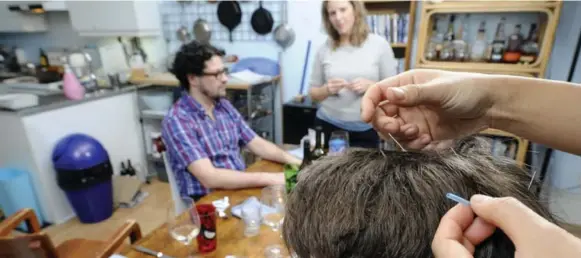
[0,88,145,224]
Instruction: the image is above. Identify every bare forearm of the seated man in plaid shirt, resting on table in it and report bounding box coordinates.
[198,168,277,189]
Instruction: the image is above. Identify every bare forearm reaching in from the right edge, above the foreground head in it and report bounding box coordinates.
[490,76,581,154]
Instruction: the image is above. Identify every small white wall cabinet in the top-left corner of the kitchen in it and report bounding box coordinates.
[0,1,47,32]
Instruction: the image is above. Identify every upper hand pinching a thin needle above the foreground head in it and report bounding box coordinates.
[361,70,495,149]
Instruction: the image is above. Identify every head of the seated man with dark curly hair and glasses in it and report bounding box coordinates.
[172,40,228,99]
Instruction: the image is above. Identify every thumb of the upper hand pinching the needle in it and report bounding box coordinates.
[385,84,448,107]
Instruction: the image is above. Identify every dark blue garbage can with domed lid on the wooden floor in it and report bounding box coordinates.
[52,134,113,223]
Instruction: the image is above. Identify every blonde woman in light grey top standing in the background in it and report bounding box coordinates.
[309,1,397,148]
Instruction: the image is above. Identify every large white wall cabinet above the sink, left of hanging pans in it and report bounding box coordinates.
[66,1,161,37]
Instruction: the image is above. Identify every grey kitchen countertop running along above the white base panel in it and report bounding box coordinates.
[0,85,140,116]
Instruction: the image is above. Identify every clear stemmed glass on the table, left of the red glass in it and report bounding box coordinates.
[167,197,201,245]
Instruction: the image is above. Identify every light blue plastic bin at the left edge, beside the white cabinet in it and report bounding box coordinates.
[0,168,44,231]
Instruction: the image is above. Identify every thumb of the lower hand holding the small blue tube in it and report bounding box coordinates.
[470,194,554,247]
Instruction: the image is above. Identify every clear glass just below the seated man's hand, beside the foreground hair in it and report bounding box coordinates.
[260,185,286,231]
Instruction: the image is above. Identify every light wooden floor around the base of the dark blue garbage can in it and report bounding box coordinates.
[44,180,172,245]
